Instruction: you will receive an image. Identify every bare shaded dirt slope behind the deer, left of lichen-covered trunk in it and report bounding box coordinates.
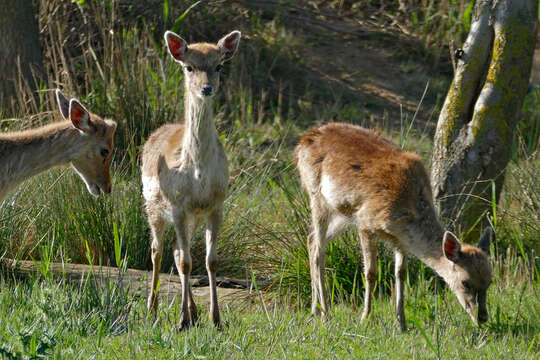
[235,1,452,130]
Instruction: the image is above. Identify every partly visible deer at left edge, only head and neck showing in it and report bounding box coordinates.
[0,89,116,200]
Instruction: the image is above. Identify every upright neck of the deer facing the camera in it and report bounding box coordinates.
[180,93,217,164]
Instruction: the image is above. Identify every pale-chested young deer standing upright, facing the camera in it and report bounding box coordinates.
[142,31,241,329]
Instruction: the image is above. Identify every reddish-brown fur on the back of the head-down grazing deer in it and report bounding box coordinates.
[295,123,431,230]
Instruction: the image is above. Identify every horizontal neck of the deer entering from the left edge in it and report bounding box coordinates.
[0,122,83,194]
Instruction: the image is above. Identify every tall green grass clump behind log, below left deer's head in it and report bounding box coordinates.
[0,162,149,268]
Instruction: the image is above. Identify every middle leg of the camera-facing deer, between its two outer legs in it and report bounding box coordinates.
[173,209,197,330]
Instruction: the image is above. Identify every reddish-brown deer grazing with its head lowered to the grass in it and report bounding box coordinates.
[295,123,491,330]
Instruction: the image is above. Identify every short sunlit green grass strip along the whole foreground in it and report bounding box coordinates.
[0,258,540,359]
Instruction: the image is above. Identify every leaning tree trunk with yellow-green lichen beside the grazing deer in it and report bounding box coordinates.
[431,0,538,238]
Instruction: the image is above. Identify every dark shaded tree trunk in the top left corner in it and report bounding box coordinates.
[0,0,43,111]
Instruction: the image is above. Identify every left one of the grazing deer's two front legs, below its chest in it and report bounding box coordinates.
[359,231,377,322]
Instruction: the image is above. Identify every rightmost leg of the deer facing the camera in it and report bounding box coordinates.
[206,208,222,328]
